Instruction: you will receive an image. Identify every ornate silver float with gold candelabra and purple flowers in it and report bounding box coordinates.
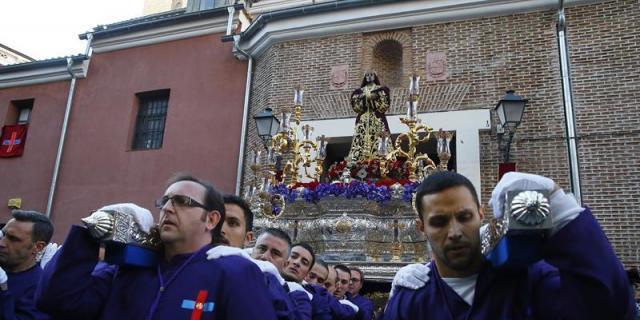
[244,76,453,281]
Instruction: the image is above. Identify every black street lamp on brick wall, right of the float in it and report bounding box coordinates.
[495,90,529,163]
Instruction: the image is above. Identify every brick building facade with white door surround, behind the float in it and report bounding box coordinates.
[239,1,640,265]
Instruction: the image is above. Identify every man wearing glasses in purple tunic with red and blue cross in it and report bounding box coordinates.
[37,175,276,319]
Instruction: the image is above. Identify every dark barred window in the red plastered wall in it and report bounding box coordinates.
[131,89,169,150]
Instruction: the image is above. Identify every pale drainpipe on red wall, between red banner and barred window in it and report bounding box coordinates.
[45,33,93,218]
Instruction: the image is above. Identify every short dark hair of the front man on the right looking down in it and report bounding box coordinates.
[416,171,480,220]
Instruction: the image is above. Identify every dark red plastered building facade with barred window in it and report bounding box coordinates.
[0,8,247,241]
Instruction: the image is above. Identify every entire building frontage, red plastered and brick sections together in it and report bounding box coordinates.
[0,0,640,266]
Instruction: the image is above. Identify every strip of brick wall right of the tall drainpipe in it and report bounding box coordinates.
[567,1,640,265]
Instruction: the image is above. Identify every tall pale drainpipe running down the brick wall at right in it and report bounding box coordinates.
[556,0,582,203]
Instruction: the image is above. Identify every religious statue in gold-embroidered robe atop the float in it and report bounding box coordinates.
[347,72,391,164]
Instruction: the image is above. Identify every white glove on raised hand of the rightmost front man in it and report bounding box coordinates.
[489,172,584,234]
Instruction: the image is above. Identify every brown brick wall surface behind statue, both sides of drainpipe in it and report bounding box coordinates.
[244,1,640,265]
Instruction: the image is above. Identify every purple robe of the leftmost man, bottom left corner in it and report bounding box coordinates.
[0,263,49,320]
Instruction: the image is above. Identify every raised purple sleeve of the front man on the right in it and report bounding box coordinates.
[539,209,634,319]
